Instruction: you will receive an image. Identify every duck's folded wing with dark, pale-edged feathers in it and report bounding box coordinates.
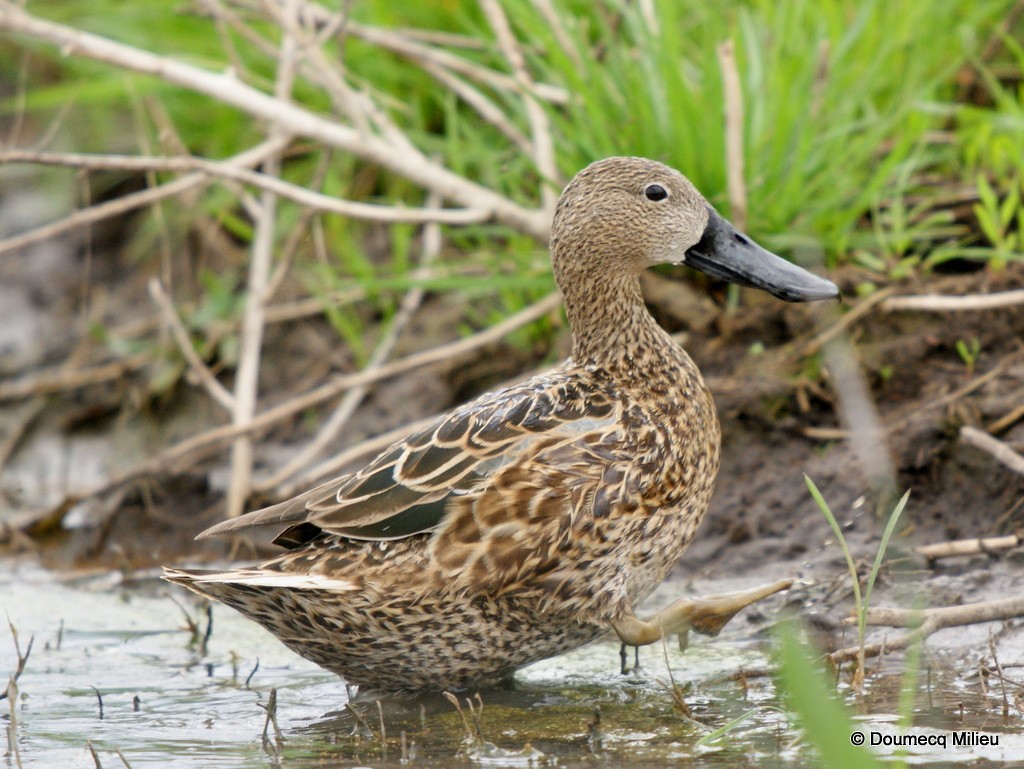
[200,370,621,547]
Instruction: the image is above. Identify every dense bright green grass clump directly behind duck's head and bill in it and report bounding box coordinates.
[512,0,1008,264]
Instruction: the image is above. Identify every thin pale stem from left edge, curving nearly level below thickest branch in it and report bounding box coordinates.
[0,149,489,224]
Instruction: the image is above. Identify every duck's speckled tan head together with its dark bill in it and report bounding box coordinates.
[551,158,839,302]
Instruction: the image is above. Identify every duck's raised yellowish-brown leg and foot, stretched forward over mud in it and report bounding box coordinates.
[611,580,793,646]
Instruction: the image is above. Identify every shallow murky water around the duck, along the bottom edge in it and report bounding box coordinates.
[0,567,1024,769]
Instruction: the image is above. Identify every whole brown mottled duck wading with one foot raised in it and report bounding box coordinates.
[164,157,839,692]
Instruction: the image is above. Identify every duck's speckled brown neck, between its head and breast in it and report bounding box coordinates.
[563,270,685,375]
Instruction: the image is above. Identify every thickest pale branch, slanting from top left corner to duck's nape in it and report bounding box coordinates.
[0,0,551,243]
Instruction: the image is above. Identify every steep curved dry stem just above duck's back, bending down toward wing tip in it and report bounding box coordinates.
[256,194,441,492]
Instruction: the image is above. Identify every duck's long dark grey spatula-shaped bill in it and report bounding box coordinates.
[686,206,839,302]
